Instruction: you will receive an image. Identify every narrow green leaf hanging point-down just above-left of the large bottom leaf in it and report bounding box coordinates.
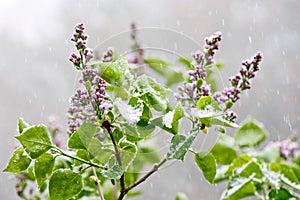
[34,153,55,189]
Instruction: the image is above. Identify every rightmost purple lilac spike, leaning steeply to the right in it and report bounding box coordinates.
[213,53,262,104]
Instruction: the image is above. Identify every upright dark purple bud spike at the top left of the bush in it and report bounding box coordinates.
[69,23,93,69]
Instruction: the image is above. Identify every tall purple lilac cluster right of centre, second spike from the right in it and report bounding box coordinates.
[176,32,222,106]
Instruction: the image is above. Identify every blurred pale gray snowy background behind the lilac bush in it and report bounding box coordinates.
[0,0,300,200]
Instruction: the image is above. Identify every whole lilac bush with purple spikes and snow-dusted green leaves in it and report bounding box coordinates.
[3,24,300,200]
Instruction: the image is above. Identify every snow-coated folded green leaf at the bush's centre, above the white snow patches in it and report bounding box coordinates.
[134,75,170,111]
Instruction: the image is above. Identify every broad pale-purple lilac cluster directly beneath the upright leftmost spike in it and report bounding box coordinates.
[68,66,111,134]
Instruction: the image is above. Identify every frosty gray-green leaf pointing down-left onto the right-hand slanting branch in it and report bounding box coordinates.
[167,127,200,160]
